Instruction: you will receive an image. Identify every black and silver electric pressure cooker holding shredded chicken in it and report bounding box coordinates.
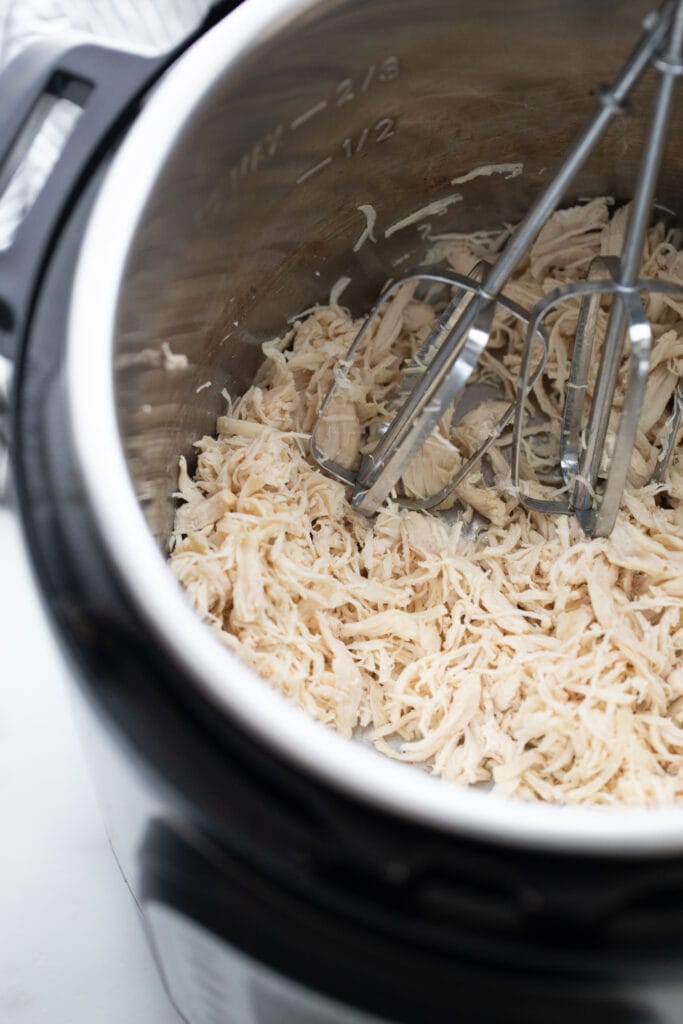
[0,0,683,1024]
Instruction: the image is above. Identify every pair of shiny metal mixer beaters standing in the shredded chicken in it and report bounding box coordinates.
[310,0,683,537]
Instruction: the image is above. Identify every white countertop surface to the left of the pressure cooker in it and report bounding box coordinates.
[0,509,180,1024]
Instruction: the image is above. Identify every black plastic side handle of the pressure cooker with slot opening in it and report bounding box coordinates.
[0,0,237,357]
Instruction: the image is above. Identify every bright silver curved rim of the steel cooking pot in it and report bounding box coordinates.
[67,0,683,855]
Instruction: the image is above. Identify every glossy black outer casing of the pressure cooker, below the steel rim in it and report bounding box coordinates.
[5,140,683,1024]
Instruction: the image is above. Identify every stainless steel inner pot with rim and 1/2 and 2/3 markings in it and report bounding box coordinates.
[68,0,683,852]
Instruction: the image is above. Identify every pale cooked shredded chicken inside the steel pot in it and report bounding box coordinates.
[170,199,683,805]
